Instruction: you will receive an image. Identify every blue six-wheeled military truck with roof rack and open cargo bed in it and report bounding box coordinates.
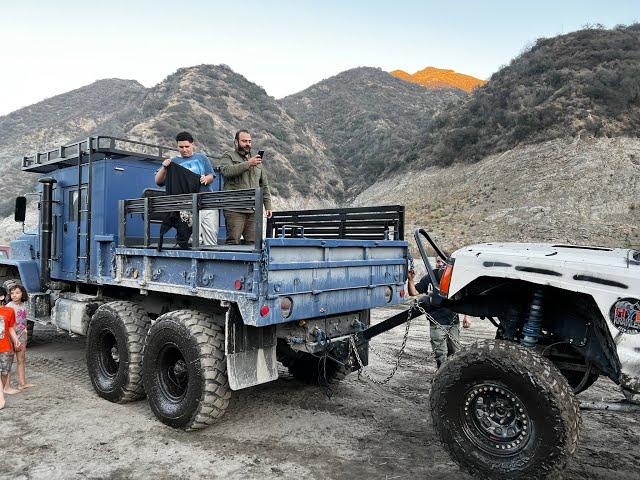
[0,136,409,429]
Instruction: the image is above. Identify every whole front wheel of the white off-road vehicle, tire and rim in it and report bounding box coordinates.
[431,340,580,479]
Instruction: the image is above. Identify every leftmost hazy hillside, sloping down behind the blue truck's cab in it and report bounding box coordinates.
[0,79,146,216]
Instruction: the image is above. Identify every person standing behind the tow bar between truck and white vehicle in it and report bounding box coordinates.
[407,257,471,368]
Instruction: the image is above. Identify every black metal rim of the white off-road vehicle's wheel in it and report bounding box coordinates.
[462,382,533,457]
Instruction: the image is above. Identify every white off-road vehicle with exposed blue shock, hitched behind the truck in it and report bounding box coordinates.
[416,230,640,478]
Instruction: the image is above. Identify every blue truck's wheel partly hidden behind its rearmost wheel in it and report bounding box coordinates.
[87,301,151,403]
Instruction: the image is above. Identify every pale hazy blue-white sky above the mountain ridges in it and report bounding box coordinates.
[0,0,640,115]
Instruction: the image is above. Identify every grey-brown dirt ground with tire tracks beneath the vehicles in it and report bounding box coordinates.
[0,309,640,480]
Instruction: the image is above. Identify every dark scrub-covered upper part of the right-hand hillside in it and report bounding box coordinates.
[404,24,640,167]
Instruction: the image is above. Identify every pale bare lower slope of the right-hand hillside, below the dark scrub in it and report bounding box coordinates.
[355,137,640,249]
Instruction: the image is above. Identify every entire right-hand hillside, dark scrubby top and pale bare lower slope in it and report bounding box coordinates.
[356,25,640,248]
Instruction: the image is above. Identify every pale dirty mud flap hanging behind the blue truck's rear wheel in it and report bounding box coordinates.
[225,305,278,390]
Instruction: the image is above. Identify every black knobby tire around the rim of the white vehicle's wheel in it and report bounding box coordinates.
[430,340,581,479]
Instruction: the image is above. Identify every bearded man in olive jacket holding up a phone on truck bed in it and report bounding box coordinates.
[220,130,272,245]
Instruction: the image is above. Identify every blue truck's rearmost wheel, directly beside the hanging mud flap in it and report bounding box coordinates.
[143,310,231,430]
